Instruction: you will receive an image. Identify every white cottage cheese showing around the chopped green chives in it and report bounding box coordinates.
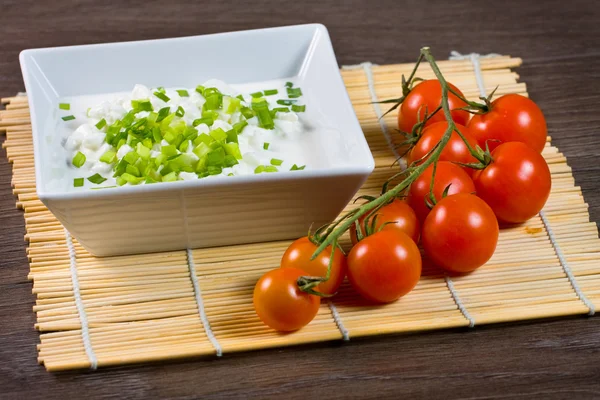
[59,80,323,190]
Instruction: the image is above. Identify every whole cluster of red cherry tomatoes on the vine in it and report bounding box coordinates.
[254,71,551,331]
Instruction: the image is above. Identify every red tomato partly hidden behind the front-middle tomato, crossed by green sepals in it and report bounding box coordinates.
[350,199,421,244]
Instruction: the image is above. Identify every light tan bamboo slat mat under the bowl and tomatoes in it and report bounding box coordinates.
[0,57,600,371]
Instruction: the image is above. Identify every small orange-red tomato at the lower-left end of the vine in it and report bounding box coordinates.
[254,268,321,331]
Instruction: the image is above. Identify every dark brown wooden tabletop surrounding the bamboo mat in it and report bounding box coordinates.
[0,0,600,399]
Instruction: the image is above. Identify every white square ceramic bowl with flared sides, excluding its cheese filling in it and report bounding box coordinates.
[20,24,374,256]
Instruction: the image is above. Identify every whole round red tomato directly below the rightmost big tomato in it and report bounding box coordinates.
[421,193,498,272]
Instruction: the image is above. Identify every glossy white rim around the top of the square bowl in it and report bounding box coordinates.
[19,23,375,203]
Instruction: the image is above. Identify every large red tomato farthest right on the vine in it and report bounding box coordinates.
[473,142,552,223]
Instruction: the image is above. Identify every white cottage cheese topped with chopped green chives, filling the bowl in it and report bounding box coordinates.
[59,80,319,190]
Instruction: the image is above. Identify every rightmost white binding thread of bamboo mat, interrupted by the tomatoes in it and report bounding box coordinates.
[450,51,596,315]
